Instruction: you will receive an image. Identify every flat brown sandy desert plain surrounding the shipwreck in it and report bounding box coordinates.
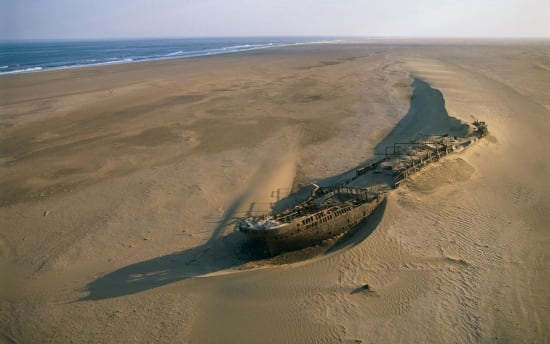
[0,41,550,343]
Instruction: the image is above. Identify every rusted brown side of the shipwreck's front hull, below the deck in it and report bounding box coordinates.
[239,193,385,255]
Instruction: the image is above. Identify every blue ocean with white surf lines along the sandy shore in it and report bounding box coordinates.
[0,37,338,75]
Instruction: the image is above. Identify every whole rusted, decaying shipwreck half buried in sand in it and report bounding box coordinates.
[238,118,488,255]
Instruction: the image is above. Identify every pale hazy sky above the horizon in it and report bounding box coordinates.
[0,0,550,39]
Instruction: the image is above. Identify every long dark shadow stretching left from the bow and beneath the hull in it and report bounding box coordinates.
[78,201,386,301]
